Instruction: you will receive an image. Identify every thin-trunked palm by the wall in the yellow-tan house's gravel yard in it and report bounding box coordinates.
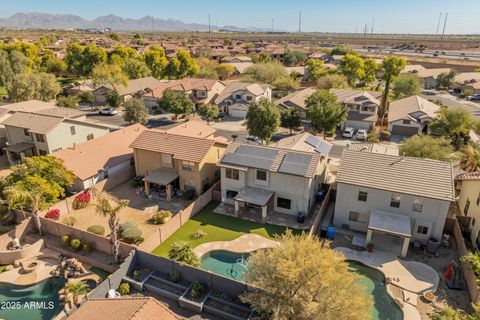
[95,192,128,263]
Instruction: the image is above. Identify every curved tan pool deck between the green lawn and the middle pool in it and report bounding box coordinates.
[193,234,280,257]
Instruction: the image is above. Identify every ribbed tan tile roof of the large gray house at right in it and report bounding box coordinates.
[337,150,455,201]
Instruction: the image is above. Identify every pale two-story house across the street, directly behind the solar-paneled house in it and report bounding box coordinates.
[214,82,272,118]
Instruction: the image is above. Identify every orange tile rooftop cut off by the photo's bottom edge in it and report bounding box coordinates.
[68,297,180,320]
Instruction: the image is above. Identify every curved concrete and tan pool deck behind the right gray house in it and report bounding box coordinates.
[334,247,440,320]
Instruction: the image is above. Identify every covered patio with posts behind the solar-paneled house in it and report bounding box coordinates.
[233,187,274,223]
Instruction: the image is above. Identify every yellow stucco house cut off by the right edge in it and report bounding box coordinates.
[455,172,480,250]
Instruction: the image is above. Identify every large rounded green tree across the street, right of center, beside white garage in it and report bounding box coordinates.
[305,90,348,138]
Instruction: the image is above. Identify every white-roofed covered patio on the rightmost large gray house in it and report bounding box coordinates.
[365,211,412,257]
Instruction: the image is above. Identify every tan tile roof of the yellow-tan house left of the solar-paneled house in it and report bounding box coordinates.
[130,130,215,162]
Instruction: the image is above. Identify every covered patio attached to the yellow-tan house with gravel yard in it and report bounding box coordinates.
[143,169,179,201]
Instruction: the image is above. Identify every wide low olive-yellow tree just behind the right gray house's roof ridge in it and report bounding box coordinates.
[400,135,453,160]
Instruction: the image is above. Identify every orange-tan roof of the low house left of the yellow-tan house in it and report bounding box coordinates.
[52,124,145,180]
